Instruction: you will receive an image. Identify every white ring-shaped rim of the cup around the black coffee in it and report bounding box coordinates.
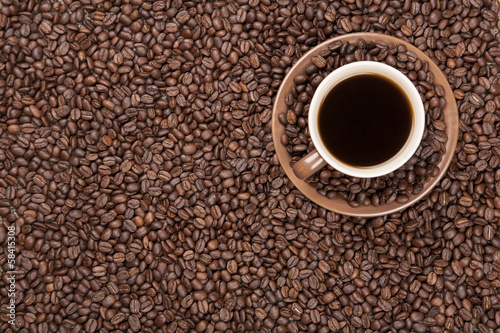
[308,61,425,178]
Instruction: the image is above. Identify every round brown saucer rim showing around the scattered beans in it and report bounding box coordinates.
[272,33,458,217]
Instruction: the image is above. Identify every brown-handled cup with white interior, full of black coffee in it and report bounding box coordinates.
[293,61,425,179]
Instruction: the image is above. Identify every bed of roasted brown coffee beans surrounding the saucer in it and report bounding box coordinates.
[0,0,500,333]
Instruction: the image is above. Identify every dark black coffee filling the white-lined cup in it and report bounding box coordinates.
[318,74,413,167]
